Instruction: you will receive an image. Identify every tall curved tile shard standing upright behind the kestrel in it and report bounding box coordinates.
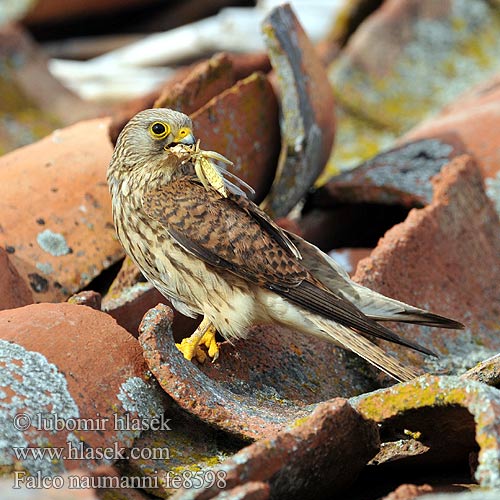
[262,5,335,217]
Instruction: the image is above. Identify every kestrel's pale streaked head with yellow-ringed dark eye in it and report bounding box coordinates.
[110,108,196,182]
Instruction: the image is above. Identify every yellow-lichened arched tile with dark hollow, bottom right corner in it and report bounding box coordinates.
[350,375,500,488]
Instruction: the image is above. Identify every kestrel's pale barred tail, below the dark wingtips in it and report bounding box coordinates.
[305,312,418,382]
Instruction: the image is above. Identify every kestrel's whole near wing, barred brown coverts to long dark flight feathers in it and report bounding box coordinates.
[143,178,433,354]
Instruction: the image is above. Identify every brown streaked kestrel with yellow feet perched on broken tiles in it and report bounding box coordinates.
[108,109,462,380]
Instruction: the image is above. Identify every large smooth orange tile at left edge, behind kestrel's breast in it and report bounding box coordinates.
[0,118,123,302]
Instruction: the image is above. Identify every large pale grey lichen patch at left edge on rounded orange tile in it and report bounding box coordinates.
[0,340,79,476]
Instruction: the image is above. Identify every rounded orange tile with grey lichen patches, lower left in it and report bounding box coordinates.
[0,303,165,477]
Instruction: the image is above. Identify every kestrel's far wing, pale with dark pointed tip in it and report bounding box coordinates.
[287,233,464,329]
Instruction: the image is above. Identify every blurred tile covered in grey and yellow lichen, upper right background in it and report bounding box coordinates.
[328,0,500,175]
